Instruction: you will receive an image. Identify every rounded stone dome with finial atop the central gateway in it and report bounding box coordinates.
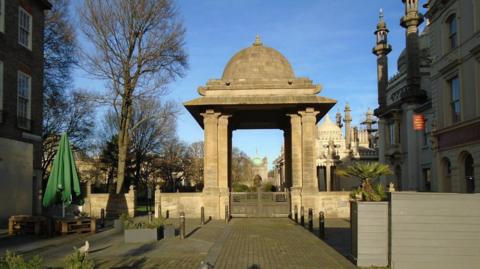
[222,36,295,81]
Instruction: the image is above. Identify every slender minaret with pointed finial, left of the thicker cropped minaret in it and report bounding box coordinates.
[373,9,392,116]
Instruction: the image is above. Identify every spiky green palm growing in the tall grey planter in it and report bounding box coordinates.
[337,162,392,201]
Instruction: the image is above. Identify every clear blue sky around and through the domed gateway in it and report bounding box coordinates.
[75,0,424,169]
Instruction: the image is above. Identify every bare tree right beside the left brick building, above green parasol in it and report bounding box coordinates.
[42,0,94,180]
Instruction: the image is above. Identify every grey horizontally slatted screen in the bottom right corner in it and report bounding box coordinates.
[390,192,480,269]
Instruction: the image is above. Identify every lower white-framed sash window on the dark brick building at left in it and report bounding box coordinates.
[17,71,32,130]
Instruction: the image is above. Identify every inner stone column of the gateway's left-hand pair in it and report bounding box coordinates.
[217,115,230,192]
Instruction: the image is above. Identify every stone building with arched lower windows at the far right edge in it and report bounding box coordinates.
[425,0,480,193]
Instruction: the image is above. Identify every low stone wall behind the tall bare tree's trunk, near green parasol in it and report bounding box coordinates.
[83,184,136,218]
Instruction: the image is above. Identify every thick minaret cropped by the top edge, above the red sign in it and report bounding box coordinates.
[400,0,425,102]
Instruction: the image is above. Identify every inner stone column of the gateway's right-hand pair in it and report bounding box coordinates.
[288,114,303,190]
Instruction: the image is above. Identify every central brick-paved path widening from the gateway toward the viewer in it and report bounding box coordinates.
[215,219,356,269]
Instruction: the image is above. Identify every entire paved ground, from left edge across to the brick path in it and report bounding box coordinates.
[0,218,356,269]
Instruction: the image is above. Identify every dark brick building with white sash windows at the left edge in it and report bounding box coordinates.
[0,0,51,221]
